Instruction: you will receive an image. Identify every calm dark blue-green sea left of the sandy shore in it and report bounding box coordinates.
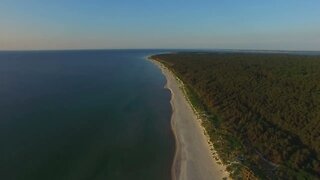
[0,50,175,180]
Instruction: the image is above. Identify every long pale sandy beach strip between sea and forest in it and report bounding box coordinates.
[152,60,228,180]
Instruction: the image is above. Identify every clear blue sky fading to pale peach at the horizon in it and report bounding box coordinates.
[0,0,320,51]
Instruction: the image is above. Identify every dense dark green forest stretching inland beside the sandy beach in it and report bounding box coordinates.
[151,53,320,179]
